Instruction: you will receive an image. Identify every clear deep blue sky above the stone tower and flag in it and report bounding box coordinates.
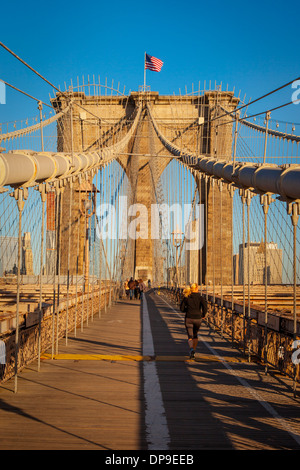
[0,0,300,123]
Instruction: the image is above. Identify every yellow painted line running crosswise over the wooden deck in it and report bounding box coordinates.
[41,353,248,363]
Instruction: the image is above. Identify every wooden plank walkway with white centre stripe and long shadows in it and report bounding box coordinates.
[0,293,300,451]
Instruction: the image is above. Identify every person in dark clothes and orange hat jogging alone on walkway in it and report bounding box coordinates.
[180,283,207,359]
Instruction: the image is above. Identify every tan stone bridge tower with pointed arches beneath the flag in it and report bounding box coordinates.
[52,91,238,285]
